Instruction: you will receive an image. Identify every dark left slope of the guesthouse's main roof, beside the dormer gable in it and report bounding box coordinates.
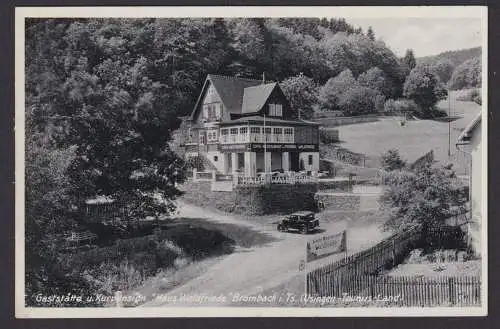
[207,74,262,113]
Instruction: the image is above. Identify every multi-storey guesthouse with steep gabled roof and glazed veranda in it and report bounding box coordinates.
[185,74,319,177]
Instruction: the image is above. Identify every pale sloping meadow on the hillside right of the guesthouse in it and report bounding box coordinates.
[332,93,481,174]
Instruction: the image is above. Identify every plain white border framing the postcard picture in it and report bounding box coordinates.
[15,6,488,318]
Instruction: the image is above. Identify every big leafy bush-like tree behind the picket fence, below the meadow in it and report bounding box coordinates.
[381,152,468,232]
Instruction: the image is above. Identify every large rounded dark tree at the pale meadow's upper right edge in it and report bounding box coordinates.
[403,66,447,117]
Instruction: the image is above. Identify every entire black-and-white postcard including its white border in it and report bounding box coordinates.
[15,6,488,318]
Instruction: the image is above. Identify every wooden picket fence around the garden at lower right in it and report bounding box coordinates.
[306,228,480,306]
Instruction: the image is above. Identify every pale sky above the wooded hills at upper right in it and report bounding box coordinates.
[346,17,482,57]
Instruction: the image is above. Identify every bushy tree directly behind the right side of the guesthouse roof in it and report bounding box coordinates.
[280,73,318,119]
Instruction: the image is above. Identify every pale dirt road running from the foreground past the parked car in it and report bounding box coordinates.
[143,203,384,306]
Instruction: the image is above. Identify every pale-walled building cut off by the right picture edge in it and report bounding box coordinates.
[457,112,483,253]
